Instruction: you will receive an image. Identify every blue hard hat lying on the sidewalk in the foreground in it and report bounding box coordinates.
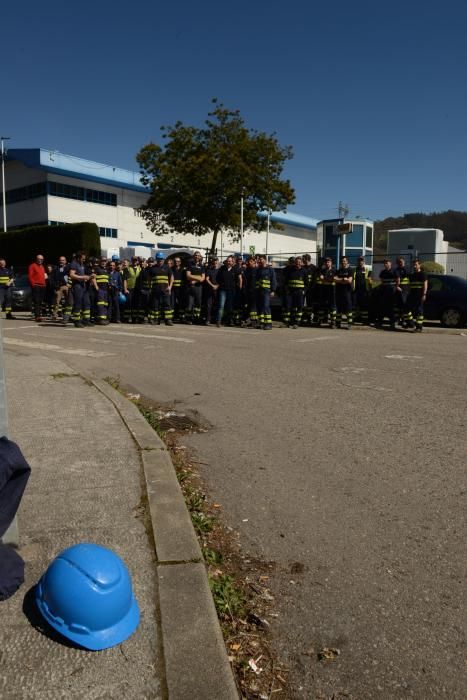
[35,544,139,651]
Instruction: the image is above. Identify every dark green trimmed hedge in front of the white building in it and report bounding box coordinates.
[0,222,101,267]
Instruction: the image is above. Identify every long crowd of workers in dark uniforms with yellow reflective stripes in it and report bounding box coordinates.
[0,251,428,331]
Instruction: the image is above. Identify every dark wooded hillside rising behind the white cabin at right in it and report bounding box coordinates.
[374,209,467,254]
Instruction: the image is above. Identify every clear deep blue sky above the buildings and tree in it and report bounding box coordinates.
[0,0,467,219]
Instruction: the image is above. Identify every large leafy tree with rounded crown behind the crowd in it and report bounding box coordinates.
[136,100,295,251]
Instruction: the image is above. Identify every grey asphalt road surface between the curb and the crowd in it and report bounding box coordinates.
[3,319,467,698]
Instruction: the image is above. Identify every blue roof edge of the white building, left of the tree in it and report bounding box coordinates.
[7,148,148,192]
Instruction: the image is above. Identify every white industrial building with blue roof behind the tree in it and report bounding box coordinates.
[0,148,317,260]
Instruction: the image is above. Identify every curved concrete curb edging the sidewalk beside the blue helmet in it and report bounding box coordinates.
[90,379,239,700]
